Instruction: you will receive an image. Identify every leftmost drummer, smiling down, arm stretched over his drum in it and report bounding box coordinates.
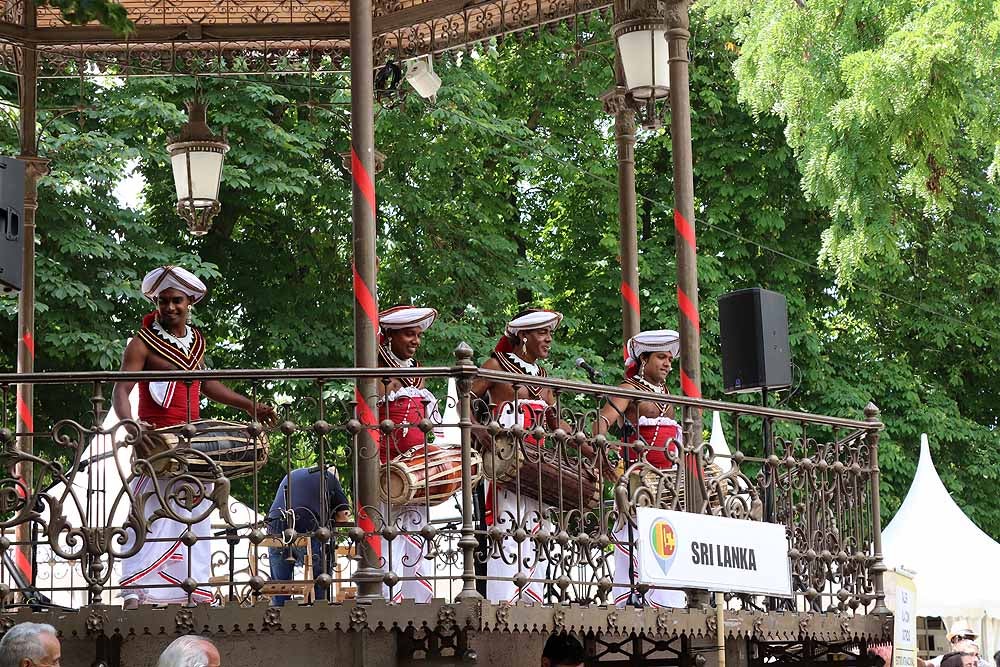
[113,266,275,609]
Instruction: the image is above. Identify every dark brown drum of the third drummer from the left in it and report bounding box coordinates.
[483,433,603,511]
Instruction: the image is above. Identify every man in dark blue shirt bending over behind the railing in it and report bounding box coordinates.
[267,467,350,607]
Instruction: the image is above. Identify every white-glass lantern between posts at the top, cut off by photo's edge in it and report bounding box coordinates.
[611,0,670,104]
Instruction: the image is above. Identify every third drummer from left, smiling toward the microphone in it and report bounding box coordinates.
[472,309,563,604]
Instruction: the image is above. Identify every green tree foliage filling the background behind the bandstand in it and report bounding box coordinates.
[0,0,1000,535]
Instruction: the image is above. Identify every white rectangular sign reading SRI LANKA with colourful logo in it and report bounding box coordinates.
[635,507,792,597]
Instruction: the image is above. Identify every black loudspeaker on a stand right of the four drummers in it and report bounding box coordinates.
[719,287,792,394]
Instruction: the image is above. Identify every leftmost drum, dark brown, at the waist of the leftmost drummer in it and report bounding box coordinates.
[142,419,270,480]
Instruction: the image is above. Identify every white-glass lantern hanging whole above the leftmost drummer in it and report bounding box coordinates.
[167,97,229,236]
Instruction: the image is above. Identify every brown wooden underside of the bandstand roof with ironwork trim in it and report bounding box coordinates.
[0,0,611,77]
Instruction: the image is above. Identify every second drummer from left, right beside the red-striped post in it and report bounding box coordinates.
[378,306,441,602]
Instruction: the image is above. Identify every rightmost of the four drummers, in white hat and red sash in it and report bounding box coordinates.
[595,329,685,607]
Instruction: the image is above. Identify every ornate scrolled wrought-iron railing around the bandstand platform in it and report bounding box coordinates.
[0,346,884,613]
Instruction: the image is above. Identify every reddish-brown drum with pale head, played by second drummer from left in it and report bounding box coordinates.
[379,445,483,507]
